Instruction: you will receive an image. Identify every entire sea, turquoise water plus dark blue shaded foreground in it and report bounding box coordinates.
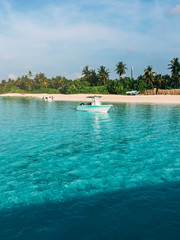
[0,96,180,240]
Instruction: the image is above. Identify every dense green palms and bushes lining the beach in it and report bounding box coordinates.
[0,58,180,94]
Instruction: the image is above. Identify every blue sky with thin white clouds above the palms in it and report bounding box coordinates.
[0,0,180,80]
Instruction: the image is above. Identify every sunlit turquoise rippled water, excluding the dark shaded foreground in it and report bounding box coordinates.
[0,98,180,208]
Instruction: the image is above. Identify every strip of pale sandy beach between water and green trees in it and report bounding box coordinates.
[0,93,180,104]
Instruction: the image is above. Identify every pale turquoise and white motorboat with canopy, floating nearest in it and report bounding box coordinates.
[77,96,112,113]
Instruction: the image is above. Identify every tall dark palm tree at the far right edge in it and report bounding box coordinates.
[168,58,180,88]
